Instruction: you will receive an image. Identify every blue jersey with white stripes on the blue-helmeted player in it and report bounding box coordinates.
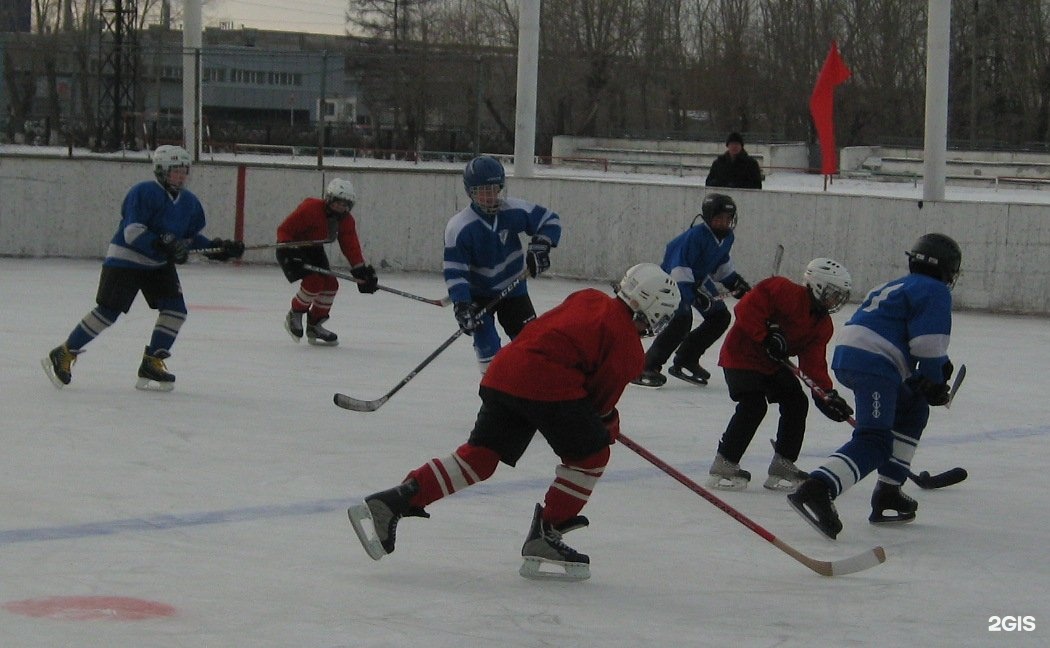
[443,197,562,301]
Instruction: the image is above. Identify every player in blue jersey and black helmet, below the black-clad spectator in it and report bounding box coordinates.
[632,193,751,388]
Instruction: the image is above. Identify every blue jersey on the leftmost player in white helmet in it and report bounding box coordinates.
[102,180,211,269]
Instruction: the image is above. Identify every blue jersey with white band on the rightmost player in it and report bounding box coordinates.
[832,273,951,384]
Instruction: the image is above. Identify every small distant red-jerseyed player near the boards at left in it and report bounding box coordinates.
[276,177,379,347]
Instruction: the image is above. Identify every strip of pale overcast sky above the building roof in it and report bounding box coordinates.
[203,0,347,35]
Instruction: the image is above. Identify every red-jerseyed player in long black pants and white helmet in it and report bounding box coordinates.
[708,258,853,490]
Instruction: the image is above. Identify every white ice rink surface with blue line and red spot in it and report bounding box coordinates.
[0,258,1050,648]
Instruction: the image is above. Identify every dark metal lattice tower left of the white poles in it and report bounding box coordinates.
[96,0,140,150]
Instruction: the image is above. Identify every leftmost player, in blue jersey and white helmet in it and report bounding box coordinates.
[41,145,245,392]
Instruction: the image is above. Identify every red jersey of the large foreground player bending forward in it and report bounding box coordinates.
[481,289,645,414]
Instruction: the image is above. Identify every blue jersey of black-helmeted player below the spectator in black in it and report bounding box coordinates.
[660,223,736,311]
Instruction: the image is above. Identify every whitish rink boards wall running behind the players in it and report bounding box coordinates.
[6,151,1050,315]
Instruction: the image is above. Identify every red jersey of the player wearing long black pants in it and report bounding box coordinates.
[718,276,835,391]
